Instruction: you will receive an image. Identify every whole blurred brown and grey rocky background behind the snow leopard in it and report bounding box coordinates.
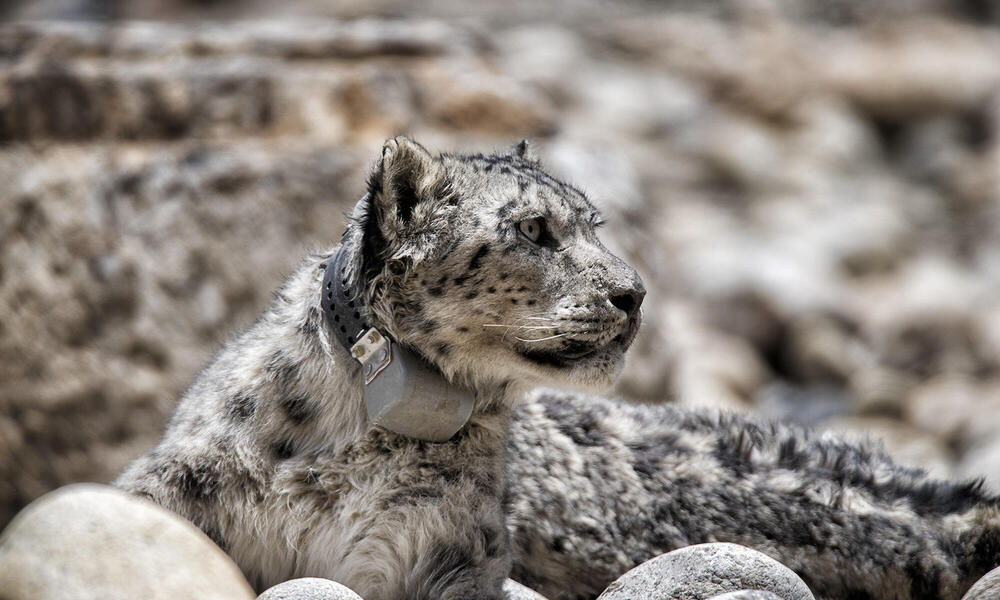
[0,0,1000,525]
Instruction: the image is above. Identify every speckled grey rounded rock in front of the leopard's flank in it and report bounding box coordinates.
[599,543,813,600]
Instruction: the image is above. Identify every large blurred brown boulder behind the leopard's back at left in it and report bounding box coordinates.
[0,142,367,527]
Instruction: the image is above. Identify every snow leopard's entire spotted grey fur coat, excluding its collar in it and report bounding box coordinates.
[116,138,1000,600]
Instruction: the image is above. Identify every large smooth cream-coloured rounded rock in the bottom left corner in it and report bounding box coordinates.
[0,484,254,600]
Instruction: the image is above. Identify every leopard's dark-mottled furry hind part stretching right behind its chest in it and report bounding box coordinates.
[506,391,1000,600]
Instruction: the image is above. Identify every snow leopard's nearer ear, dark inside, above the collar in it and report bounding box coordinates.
[368,136,443,230]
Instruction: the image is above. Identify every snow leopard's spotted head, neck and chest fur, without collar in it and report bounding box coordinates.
[116,138,644,600]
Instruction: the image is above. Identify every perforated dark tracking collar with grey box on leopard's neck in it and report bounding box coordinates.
[320,195,475,442]
